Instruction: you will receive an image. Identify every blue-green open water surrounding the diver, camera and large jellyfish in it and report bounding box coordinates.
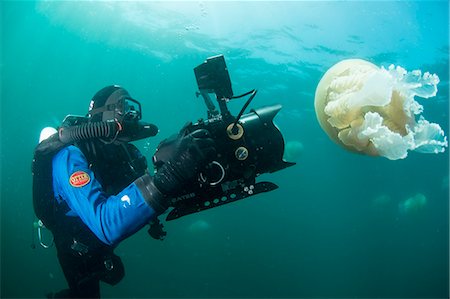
[0,1,449,298]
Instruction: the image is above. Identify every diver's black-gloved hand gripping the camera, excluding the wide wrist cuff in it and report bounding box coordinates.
[153,129,216,195]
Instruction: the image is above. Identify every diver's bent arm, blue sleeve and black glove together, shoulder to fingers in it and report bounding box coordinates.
[53,130,215,245]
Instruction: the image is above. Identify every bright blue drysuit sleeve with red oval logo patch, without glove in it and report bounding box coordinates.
[53,146,156,246]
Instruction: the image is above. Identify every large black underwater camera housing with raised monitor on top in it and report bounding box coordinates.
[153,55,295,220]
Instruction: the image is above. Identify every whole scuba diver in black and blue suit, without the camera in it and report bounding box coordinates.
[33,85,216,298]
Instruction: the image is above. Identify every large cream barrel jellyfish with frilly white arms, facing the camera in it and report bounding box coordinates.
[314,59,448,160]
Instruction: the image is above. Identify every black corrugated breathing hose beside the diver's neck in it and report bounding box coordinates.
[59,121,122,144]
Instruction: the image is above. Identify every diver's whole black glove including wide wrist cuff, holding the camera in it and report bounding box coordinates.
[135,129,216,214]
